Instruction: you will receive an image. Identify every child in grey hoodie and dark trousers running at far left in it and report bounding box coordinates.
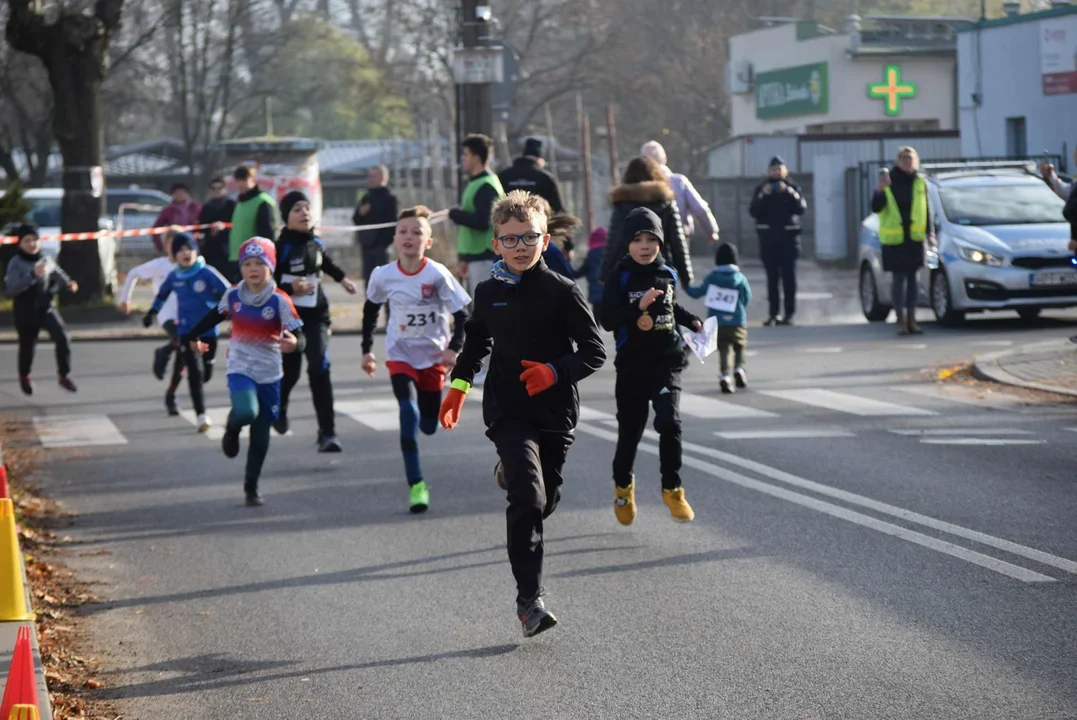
[3,225,79,395]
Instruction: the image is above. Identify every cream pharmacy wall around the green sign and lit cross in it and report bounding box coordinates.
[729,24,960,136]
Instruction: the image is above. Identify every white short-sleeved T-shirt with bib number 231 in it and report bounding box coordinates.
[366,257,471,370]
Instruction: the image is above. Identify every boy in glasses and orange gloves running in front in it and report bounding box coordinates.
[439,190,605,636]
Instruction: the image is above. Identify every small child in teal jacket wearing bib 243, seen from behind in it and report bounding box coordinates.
[685,242,752,394]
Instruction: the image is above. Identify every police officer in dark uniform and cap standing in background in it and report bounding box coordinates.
[749,156,808,325]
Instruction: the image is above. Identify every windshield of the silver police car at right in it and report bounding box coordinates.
[939,183,1065,225]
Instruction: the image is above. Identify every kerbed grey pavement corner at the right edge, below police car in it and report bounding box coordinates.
[973,339,1077,397]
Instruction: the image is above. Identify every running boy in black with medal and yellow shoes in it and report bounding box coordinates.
[602,208,703,525]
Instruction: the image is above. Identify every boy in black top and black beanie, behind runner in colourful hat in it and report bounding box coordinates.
[274,190,355,452]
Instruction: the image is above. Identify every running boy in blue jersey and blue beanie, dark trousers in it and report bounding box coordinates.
[142,232,228,433]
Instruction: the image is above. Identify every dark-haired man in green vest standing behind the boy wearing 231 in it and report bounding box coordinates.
[449,135,505,297]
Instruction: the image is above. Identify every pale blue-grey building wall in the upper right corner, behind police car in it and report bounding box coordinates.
[957,14,1077,157]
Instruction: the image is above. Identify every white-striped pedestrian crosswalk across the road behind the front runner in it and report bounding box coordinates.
[21,383,1077,448]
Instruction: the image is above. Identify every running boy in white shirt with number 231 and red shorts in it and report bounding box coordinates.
[363,206,471,512]
